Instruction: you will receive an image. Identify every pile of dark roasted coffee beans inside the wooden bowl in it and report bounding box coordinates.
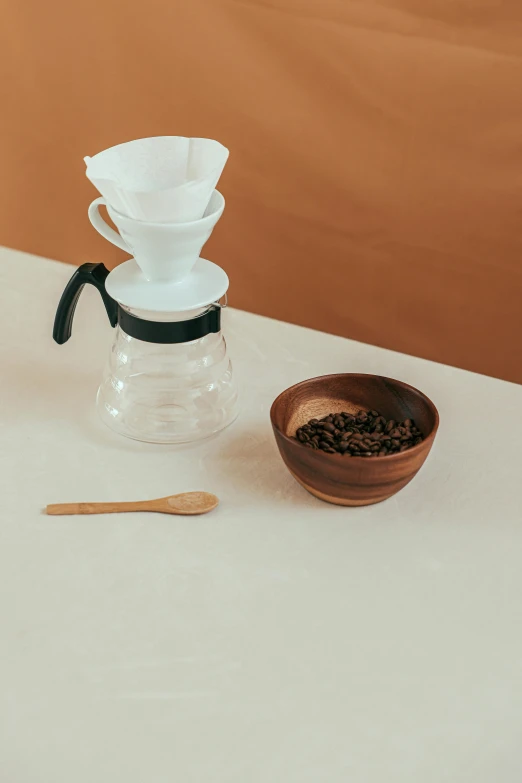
[296,411,423,457]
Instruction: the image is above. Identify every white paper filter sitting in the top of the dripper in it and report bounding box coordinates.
[84,136,228,223]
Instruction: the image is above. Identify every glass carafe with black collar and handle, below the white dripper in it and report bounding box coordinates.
[54,262,238,443]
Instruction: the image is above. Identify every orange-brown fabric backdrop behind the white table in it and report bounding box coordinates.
[0,0,522,382]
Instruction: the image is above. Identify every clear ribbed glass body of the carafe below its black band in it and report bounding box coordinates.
[97,308,237,443]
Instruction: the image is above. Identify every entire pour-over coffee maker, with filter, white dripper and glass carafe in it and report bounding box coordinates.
[53,136,237,443]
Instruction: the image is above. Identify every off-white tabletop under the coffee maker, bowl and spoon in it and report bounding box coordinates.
[0,251,522,783]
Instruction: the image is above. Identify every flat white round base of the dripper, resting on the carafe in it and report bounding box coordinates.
[105,258,229,313]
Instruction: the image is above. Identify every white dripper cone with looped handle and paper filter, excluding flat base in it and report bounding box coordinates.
[85,136,228,283]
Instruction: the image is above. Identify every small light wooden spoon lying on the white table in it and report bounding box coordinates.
[45,492,219,515]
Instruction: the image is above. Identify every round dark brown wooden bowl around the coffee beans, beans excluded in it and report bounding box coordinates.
[270,373,439,506]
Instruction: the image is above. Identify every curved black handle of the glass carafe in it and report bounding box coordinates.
[53,264,118,345]
